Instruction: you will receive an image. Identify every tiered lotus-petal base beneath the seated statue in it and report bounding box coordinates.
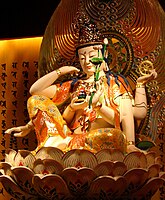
[0,147,165,200]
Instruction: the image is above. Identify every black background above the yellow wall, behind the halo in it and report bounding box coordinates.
[0,0,165,39]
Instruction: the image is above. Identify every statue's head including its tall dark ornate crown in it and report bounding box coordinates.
[76,15,107,75]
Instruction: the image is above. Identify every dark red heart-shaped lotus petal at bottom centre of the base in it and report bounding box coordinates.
[61,168,96,196]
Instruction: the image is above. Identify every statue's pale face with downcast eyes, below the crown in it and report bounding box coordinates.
[78,45,102,76]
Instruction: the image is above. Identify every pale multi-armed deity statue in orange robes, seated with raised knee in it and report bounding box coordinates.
[6,21,157,152]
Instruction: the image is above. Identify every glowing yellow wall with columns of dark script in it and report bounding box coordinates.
[0,37,42,200]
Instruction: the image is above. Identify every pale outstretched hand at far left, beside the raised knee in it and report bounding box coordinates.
[5,125,32,137]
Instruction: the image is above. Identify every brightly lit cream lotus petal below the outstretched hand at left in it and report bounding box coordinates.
[15,150,36,169]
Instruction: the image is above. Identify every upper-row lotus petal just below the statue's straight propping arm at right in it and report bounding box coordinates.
[123,151,147,170]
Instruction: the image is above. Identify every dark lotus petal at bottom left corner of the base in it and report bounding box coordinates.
[0,175,37,200]
